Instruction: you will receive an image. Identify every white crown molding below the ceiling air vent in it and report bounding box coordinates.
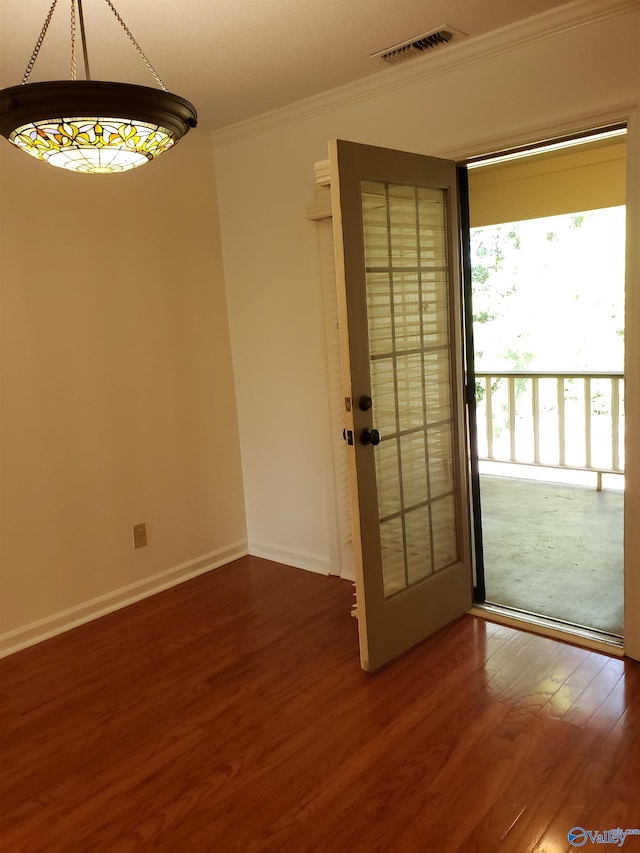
[211,0,640,148]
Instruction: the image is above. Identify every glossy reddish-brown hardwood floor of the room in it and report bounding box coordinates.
[0,558,640,853]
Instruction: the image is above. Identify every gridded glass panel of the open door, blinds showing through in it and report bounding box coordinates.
[362,181,458,597]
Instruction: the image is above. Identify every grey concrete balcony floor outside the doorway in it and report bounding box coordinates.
[480,474,624,636]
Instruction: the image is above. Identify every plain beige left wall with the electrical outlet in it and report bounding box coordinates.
[0,131,246,654]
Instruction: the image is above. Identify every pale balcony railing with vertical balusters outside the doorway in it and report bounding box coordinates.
[476,370,624,490]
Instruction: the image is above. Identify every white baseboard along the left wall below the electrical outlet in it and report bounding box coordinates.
[0,541,249,658]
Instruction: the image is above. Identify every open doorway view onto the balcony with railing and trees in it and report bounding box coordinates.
[469,127,626,637]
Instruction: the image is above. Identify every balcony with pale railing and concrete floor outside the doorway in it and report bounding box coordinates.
[476,371,624,635]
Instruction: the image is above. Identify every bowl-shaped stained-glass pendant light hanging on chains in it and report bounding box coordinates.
[0,0,197,175]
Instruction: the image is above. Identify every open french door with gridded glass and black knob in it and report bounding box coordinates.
[330,141,472,671]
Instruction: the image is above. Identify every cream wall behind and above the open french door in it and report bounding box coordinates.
[214,0,640,588]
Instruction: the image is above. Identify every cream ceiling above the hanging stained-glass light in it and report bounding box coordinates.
[0,0,576,130]
